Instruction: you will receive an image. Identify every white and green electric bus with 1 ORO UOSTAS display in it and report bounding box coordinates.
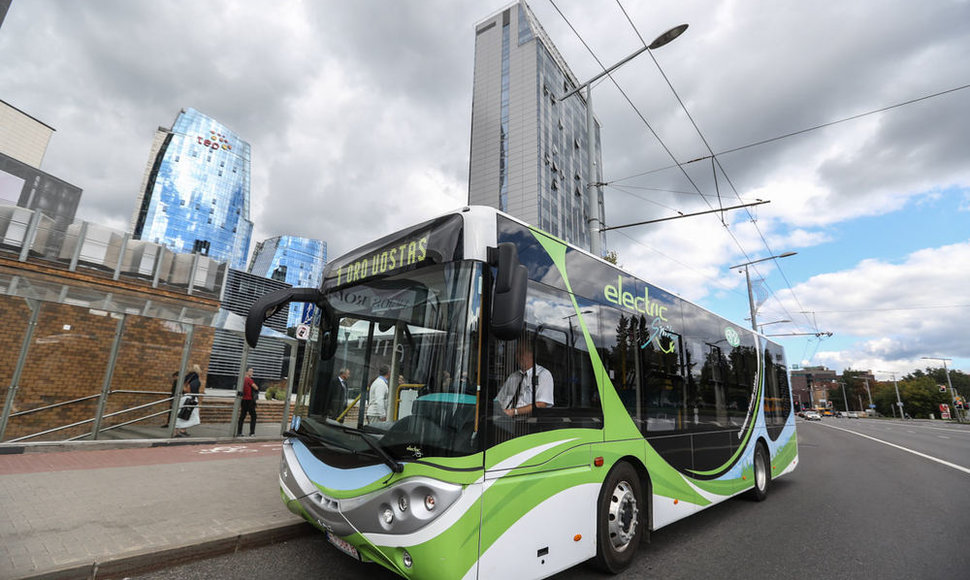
[247,207,798,579]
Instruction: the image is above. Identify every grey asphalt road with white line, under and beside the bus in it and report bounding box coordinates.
[134,418,970,580]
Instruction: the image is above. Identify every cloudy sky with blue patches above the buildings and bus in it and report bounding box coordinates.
[0,0,970,376]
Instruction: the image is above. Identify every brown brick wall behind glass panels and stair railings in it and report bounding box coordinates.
[0,296,213,441]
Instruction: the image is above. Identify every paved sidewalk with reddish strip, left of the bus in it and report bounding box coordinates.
[0,436,312,579]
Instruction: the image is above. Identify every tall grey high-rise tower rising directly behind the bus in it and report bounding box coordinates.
[468,1,604,249]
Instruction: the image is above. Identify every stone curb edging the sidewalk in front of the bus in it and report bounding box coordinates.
[20,522,316,580]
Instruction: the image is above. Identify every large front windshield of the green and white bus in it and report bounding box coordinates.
[298,262,482,464]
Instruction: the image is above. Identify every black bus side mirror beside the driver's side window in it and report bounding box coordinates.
[489,242,529,340]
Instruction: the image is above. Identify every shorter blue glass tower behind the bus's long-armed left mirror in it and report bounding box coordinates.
[249,236,327,327]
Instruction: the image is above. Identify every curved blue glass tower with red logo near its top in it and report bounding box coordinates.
[131,109,253,270]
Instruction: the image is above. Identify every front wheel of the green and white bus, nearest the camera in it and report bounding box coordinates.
[596,462,644,574]
